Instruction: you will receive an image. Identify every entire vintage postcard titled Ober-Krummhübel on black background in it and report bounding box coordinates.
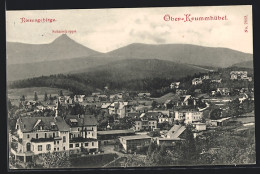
[6,5,256,170]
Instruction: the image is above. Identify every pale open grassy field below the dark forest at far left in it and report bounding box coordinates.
[7,87,71,100]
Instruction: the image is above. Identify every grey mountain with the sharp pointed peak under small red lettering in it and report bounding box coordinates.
[6,34,99,64]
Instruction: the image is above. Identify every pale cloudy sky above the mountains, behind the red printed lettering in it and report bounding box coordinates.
[6,5,253,53]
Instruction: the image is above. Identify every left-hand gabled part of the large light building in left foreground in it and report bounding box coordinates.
[11,116,69,162]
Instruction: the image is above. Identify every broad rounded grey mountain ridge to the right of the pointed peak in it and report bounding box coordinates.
[107,43,253,67]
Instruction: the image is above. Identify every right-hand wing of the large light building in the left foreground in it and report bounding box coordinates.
[65,115,98,153]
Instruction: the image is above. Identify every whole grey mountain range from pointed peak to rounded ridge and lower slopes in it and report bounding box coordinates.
[7,35,253,81]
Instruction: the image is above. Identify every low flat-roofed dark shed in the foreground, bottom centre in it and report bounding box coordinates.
[119,135,152,153]
